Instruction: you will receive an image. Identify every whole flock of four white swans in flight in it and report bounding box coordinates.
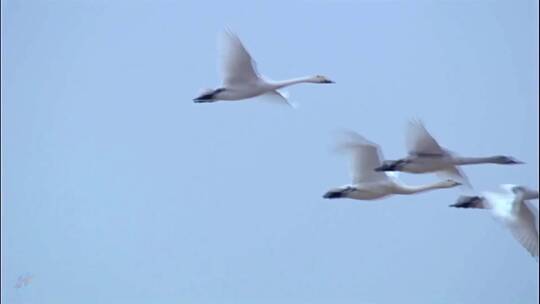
[193,31,539,258]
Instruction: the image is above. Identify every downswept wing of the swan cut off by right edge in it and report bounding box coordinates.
[507,202,538,257]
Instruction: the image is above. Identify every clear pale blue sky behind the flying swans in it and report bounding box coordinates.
[1,0,539,304]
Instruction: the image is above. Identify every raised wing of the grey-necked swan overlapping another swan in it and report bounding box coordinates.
[405,119,445,155]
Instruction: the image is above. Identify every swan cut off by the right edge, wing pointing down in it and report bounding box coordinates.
[450,185,538,258]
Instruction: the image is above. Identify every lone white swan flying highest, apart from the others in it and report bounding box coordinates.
[193,31,334,104]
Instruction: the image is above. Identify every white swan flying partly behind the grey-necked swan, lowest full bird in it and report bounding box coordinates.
[323,131,461,200]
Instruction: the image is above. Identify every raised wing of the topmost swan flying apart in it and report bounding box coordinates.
[221,30,259,87]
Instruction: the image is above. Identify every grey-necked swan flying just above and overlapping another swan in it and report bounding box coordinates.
[375,120,522,184]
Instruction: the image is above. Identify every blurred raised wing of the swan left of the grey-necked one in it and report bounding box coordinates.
[339,131,389,184]
